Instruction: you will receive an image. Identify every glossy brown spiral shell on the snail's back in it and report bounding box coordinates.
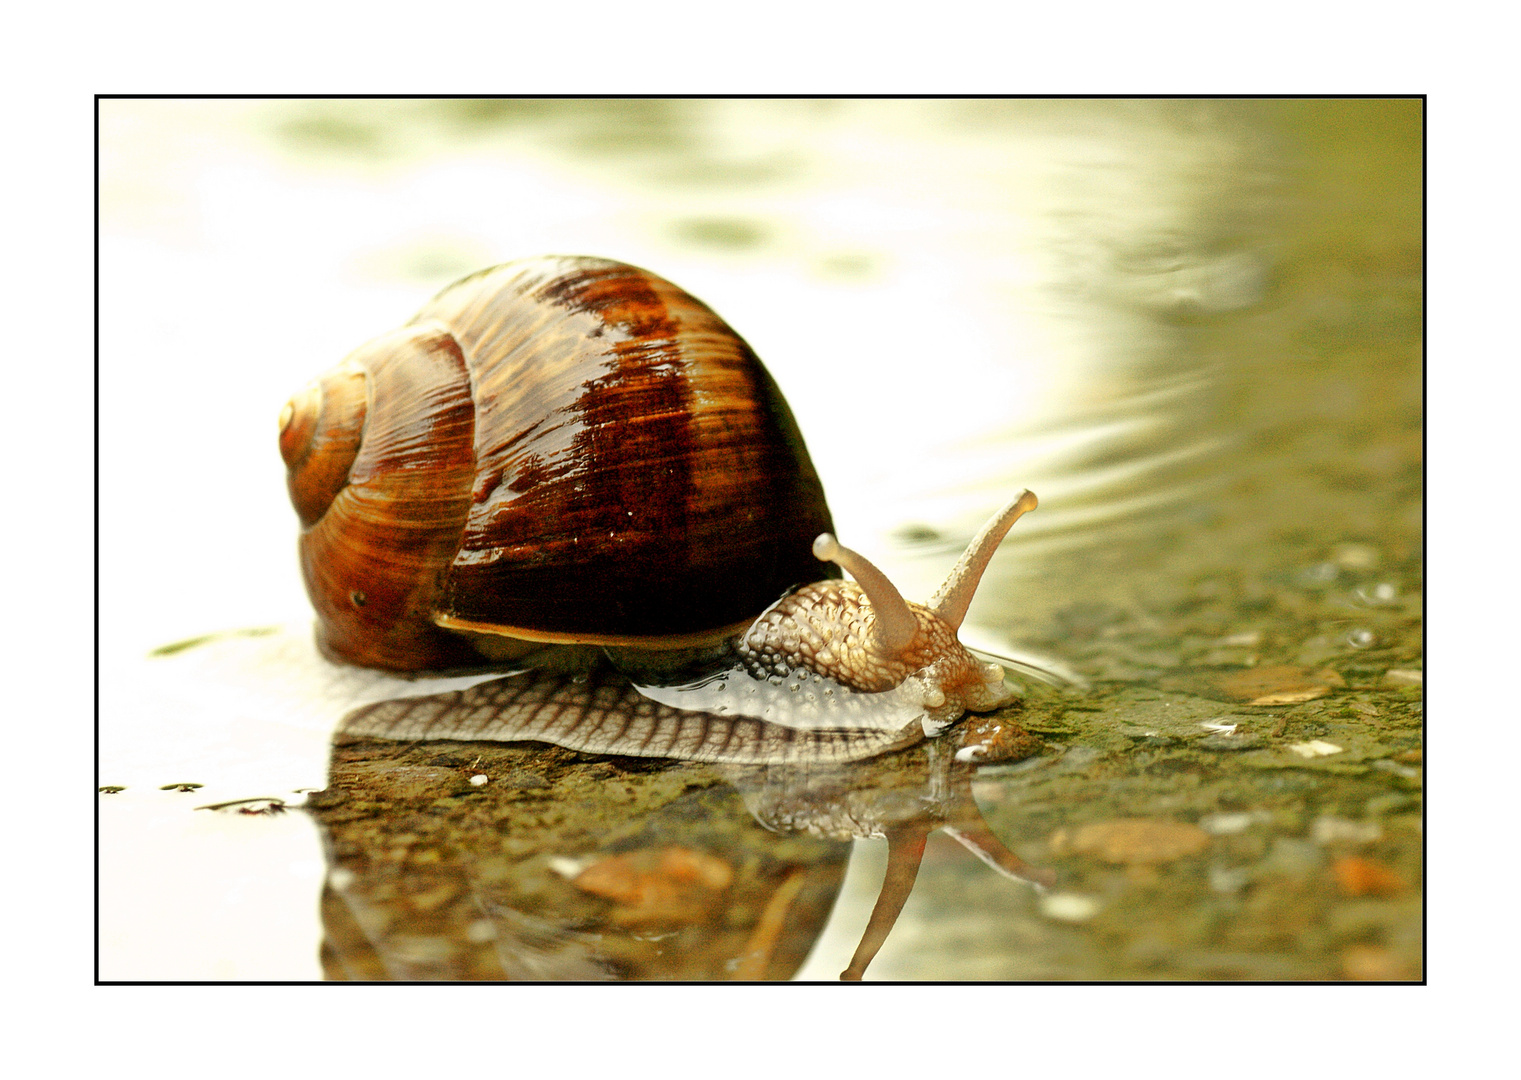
[280,257,840,671]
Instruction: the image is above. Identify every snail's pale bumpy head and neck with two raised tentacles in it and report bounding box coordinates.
[741,491,1036,723]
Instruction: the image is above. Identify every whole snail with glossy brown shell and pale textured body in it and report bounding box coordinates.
[280,257,1036,761]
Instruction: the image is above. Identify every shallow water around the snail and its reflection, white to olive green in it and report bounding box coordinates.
[100,100,1424,980]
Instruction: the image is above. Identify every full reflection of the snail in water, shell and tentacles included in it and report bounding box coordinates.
[306,718,1054,981]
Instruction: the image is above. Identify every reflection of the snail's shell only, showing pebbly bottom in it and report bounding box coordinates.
[307,742,850,981]
